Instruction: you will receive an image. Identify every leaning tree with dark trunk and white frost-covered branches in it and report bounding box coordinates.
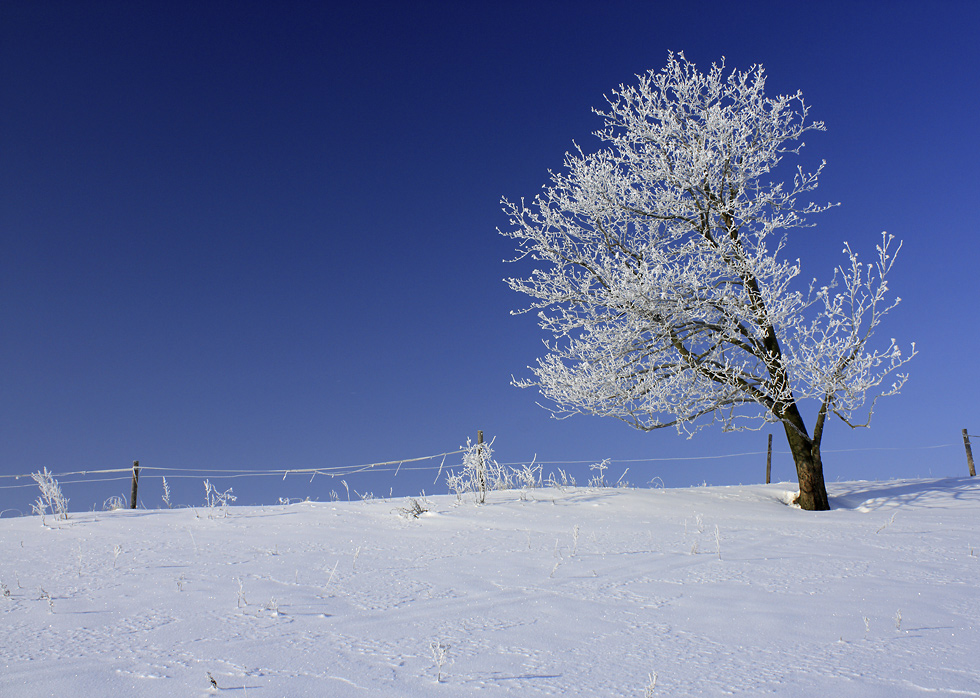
[500,54,915,510]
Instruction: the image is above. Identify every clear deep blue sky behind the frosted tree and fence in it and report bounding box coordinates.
[0,0,980,515]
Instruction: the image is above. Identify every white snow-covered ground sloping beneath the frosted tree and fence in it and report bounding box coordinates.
[0,479,980,698]
